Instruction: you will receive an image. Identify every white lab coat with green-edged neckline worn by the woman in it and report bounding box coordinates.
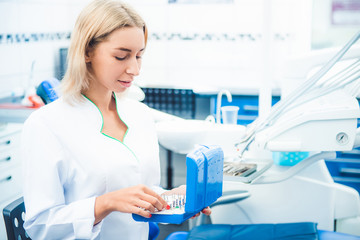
[22,96,162,240]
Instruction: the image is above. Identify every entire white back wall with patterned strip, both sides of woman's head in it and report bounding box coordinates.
[0,0,360,185]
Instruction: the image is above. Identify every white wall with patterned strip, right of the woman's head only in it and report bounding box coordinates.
[136,0,312,88]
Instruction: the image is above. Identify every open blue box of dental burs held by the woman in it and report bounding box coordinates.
[132,145,224,224]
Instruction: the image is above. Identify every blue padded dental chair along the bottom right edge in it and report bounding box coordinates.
[165,191,360,240]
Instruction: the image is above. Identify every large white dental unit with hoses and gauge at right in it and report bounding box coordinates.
[212,32,360,236]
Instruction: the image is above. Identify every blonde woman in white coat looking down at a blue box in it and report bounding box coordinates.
[22,0,210,240]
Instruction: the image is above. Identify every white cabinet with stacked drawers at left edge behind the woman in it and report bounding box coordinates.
[0,124,22,240]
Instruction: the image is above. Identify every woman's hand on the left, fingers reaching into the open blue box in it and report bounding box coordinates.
[94,184,167,224]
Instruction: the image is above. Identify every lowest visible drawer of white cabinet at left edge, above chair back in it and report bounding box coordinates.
[0,165,22,202]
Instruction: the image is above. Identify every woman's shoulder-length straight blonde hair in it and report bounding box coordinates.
[61,0,147,102]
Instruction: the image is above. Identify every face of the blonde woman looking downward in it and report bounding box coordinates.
[87,27,145,92]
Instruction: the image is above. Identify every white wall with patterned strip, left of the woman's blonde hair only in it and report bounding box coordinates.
[0,0,88,97]
